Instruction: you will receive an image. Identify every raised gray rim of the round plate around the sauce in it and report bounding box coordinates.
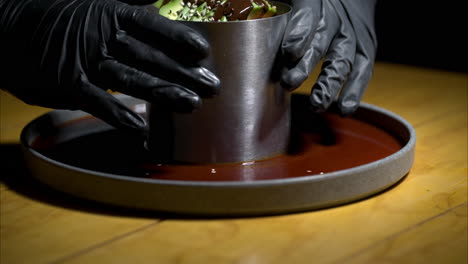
[21,95,416,215]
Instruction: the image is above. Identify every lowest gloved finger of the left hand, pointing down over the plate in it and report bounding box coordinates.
[78,77,147,134]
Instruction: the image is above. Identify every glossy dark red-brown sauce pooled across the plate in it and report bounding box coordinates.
[32,113,403,181]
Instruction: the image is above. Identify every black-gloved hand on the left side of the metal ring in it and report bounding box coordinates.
[0,0,220,132]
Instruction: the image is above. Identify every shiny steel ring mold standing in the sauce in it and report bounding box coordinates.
[147,3,291,163]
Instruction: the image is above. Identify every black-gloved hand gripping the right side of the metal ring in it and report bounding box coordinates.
[281,0,377,115]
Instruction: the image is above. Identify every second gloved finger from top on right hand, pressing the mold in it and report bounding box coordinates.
[280,1,341,91]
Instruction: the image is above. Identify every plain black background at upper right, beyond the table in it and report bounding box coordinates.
[374,0,468,72]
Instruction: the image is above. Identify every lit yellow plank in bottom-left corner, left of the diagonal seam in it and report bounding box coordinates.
[0,187,157,264]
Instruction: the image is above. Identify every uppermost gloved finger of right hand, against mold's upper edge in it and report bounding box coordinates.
[281,0,322,63]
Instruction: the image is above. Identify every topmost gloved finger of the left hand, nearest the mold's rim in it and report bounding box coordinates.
[117,6,210,59]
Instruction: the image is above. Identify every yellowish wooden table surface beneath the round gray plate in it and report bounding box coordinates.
[0,63,468,264]
